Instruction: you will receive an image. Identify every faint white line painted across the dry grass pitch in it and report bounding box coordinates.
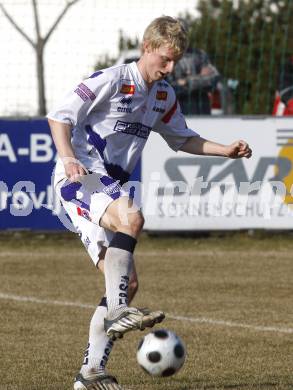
[0,293,293,334]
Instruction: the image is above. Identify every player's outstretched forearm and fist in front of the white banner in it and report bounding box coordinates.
[180,136,252,159]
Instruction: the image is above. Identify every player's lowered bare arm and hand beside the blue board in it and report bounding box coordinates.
[48,119,87,182]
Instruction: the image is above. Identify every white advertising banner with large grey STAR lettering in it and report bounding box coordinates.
[142,117,293,231]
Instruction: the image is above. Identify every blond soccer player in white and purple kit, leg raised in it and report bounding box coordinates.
[48,16,251,390]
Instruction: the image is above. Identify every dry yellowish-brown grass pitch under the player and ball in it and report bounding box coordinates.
[0,233,293,390]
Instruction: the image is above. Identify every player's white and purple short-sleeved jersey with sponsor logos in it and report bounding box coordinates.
[47,62,198,184]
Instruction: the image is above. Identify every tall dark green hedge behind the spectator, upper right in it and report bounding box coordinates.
[184,0,293,114]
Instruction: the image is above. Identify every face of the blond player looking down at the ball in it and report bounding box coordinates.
[143,46,180,83]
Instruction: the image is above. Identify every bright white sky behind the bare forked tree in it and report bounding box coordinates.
[0,0,197,116]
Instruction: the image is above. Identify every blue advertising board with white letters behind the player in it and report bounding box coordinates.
[0,119,140,231]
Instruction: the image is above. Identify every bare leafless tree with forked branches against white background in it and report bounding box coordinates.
[0,0,79,115]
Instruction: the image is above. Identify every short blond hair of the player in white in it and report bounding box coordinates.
[142,16,188,56]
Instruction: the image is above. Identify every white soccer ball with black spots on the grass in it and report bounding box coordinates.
[137,329,186,376]
